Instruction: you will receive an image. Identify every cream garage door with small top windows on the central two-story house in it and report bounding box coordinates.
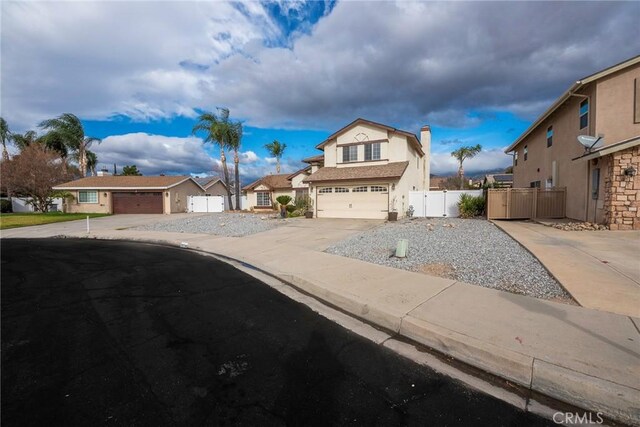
[316,184,389,219]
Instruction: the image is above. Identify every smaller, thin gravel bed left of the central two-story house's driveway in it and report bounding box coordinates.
[134,212,288,237]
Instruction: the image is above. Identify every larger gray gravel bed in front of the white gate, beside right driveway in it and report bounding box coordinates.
[327,218,573,302]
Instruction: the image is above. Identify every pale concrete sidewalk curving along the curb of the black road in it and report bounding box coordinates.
[2,222,640,425]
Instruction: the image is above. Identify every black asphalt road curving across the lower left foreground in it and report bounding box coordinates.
[1,239,552,427]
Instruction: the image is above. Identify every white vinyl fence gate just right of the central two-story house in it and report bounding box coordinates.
[409,190,482,218]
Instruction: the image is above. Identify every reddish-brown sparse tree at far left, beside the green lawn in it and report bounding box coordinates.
[0,144,74,212]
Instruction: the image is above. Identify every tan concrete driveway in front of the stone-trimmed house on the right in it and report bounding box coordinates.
[493,221,640,317]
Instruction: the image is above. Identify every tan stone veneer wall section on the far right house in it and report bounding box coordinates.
[604,146,640,230]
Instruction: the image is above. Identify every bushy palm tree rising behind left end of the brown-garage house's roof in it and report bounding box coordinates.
[40,113,101,176]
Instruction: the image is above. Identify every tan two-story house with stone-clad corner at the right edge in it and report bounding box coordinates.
[505,56,640,230]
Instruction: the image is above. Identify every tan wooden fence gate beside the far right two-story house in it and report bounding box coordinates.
[487,188,566,219]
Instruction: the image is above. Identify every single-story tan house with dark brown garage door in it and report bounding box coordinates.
[53,175,205,214]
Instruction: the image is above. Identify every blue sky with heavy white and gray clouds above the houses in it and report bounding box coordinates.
[0,0,640,181]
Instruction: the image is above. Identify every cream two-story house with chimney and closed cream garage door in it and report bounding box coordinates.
[303,119,431,219]
